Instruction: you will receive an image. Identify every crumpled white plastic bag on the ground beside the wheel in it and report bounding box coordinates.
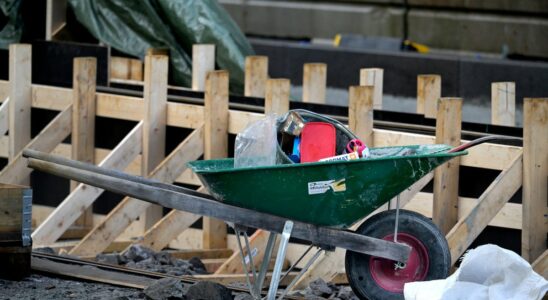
[404,245,548,300]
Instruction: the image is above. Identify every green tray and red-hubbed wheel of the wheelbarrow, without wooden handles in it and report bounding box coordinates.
[189,145,467,299]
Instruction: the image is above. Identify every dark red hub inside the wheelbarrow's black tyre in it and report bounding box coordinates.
[369,233,429,293]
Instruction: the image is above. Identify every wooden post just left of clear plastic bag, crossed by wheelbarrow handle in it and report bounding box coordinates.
[203,71,228,249]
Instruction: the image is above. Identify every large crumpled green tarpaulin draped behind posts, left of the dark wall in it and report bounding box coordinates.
[69,0,253,92]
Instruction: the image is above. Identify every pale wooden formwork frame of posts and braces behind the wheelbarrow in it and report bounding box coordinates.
[0,45,548,287]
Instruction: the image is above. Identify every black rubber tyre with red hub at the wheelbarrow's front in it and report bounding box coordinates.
[345,209,451,300]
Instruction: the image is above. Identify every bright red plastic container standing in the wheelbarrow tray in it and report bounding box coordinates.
[301,122,337,163]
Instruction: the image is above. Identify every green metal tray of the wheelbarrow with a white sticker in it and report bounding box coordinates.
[189,145,467,228]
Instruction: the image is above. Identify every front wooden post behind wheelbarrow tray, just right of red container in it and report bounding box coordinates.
[348,86,374,147]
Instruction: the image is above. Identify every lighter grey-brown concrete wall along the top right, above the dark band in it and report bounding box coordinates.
[219,0,548,58]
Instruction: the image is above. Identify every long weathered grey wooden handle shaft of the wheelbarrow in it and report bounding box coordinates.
[28,154,410,261]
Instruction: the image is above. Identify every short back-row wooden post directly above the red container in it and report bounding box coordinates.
[303,63,327,103]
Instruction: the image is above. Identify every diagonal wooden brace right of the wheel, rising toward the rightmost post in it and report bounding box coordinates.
[447,156,524,264]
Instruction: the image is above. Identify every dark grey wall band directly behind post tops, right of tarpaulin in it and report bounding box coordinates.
[252,39,548,102]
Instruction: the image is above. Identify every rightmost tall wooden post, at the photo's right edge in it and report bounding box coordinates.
[521,98,548,262]
